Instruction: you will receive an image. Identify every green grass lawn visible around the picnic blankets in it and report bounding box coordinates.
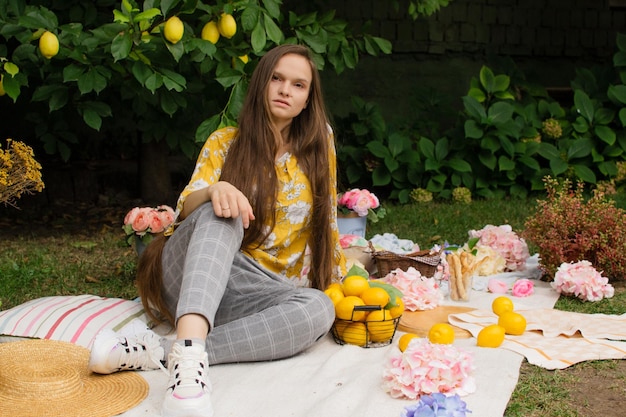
[0,197,626,417]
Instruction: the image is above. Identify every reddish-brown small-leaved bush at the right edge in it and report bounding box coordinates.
[522,177,626,280]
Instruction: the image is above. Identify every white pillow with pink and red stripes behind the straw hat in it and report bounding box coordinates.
[0,294,148,348]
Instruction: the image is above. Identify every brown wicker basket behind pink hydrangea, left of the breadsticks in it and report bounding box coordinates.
[372,244,441,278]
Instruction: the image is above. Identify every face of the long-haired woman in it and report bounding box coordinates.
[267,54,313,130]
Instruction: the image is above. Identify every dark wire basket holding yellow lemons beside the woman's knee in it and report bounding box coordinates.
[331,305,402,348]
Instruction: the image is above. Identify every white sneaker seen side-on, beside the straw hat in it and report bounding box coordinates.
[89,319,165,374]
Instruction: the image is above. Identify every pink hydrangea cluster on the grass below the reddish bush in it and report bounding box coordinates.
[552,260,615,301]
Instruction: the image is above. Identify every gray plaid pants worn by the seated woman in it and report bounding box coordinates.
[163,203,335,364]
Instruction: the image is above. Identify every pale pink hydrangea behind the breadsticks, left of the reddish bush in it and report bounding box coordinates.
[469,224,530,271]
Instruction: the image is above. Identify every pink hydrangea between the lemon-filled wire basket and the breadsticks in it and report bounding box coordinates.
[381,267,443,311]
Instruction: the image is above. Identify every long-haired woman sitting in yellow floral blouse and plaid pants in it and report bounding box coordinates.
[90,45,345,416]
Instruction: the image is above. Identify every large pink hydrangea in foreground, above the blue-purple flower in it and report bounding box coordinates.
[382,338,476,400]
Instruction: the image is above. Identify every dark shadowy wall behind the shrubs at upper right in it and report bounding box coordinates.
[294,0,626,119]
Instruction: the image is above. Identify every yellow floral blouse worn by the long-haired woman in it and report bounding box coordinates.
[176,127,346,286]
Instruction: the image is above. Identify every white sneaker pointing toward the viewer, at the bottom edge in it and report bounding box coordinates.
[162,340,213,417]
